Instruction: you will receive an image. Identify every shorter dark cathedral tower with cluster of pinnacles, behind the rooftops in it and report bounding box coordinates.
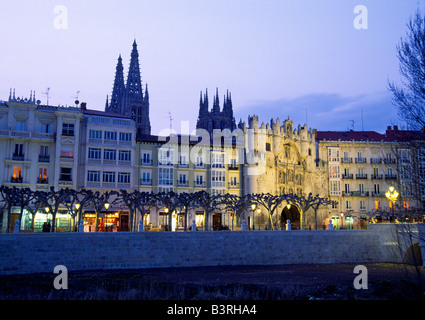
[196,88,236,136]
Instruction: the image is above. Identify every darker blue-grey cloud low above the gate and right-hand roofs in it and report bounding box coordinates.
[234,92,399,133]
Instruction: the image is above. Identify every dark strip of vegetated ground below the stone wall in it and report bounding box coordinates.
[0,264,425,300]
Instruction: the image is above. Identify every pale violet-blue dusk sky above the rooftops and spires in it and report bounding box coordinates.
[0,0,425,134]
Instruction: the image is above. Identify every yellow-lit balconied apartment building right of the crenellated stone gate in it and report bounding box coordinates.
[317,127,423,228]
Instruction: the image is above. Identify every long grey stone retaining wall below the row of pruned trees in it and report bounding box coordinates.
[0,226,399,274]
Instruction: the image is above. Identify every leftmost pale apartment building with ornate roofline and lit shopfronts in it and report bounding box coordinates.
[0,90,83,230]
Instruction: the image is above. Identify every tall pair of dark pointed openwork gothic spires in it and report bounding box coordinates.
[105,40,151,135]
